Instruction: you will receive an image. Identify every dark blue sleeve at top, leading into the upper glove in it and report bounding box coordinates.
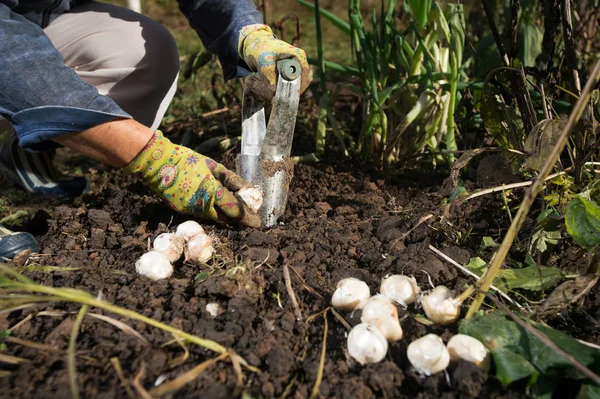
[178,0,263,80]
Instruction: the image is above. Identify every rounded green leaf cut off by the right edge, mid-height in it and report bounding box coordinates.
[565,190,600,249]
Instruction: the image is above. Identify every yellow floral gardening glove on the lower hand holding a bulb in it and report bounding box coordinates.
[125,131,260,227]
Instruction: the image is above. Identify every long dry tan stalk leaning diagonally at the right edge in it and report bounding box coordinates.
[466,60,600,318]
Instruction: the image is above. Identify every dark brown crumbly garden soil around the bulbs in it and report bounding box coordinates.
[0,106,600,399]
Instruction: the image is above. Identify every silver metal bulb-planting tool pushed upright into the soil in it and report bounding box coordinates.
[237,58,301,227]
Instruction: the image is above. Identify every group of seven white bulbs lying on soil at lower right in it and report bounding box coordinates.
[331,275,490,376]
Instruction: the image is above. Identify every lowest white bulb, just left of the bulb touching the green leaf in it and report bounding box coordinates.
[406,334,450,375]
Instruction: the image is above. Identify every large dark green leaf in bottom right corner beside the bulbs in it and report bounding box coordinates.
[459,310,600,392]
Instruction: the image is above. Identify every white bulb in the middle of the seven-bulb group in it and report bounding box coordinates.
[360,295,403,342]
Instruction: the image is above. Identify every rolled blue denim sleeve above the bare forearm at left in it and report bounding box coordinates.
[0,3,131,151]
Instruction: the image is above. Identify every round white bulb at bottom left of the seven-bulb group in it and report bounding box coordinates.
[348,323,388,364]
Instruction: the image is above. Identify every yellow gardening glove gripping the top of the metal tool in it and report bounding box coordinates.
[238,24,310,100]
